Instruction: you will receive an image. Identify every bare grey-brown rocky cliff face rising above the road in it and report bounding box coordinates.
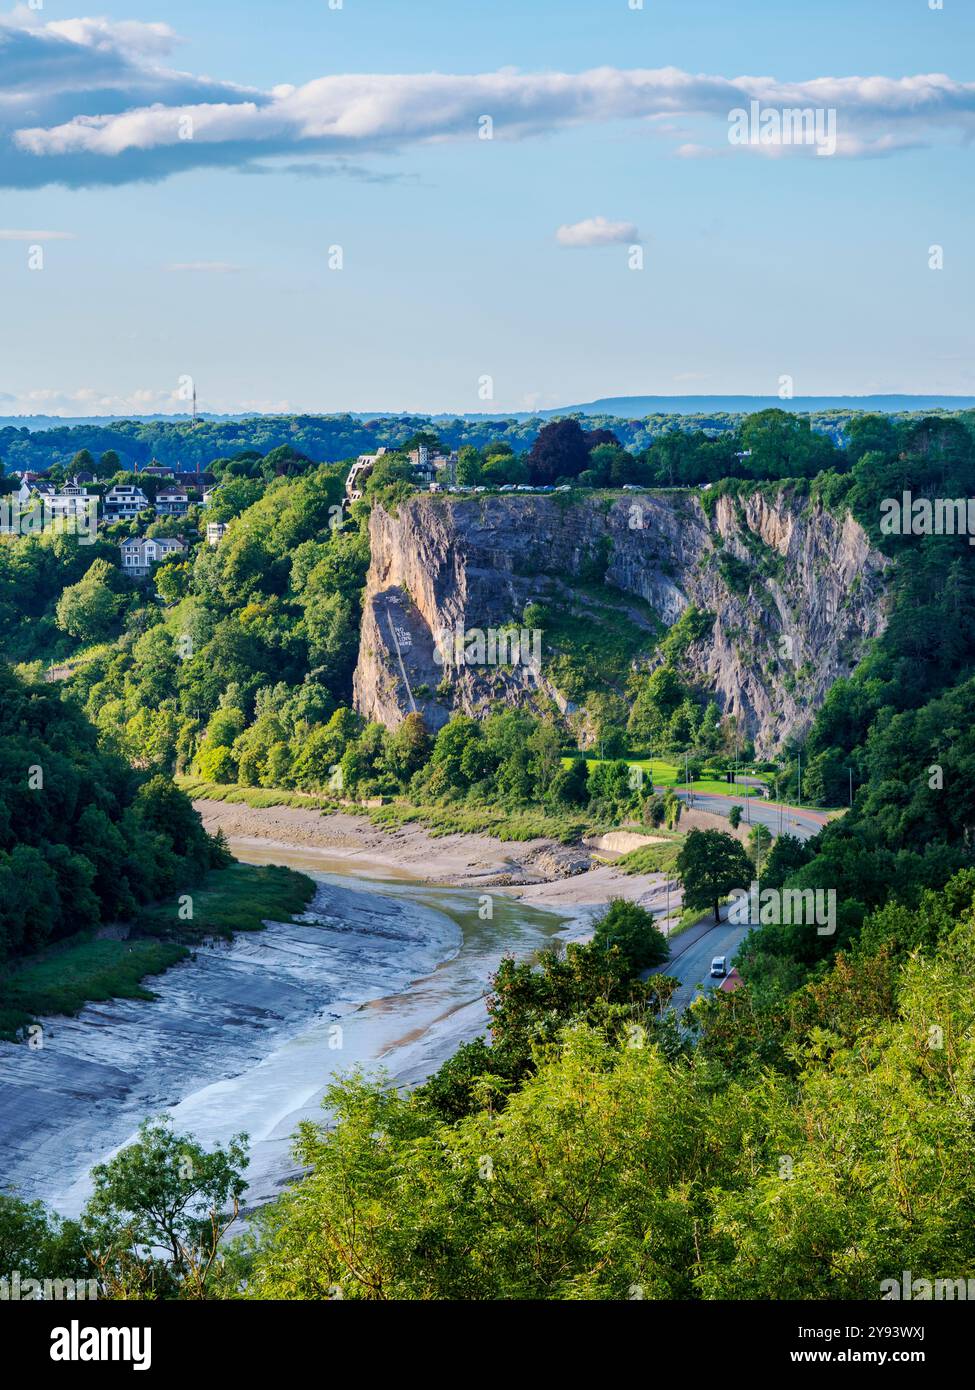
[355,489,887,755]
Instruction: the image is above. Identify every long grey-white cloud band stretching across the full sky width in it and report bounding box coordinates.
[0,7,975,188]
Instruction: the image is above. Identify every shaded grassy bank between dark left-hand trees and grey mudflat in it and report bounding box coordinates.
[0,863,314,1040]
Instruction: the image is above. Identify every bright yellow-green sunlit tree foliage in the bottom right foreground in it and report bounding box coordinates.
[248,884,975,1300]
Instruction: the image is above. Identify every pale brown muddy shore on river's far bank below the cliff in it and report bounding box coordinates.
[193,801,679,919]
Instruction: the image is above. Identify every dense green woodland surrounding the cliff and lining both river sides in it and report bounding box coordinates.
[0,411,975,1298]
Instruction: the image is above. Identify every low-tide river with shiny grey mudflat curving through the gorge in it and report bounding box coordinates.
[0,841,566,1215]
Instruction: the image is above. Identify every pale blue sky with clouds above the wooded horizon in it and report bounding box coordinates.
[0,0,975,416]
